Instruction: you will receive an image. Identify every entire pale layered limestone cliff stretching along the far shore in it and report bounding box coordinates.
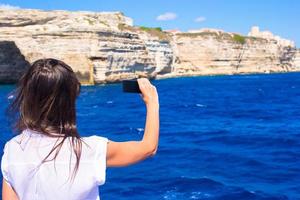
[0,10,300,84]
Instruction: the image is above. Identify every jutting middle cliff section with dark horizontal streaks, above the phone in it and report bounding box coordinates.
[89,29,173,83]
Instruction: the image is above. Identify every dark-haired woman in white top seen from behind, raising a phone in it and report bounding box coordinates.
[1,59,159,200]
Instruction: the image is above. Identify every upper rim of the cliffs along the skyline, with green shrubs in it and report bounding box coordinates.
[0,8,294,47]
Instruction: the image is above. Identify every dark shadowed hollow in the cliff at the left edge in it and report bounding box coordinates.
[0,41,30,83]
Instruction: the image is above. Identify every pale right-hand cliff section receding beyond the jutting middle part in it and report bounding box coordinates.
[166,31,300,76]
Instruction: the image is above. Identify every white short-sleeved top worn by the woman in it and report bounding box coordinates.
[1,129,108,200]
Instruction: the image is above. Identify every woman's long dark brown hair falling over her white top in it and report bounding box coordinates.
[7,58,82,178]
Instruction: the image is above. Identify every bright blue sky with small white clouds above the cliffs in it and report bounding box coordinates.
[0,0,300,47]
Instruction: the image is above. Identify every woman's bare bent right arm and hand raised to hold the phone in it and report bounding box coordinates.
[107,78,159,167]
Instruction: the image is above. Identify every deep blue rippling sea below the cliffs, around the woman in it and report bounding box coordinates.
[0,73,300,200]
